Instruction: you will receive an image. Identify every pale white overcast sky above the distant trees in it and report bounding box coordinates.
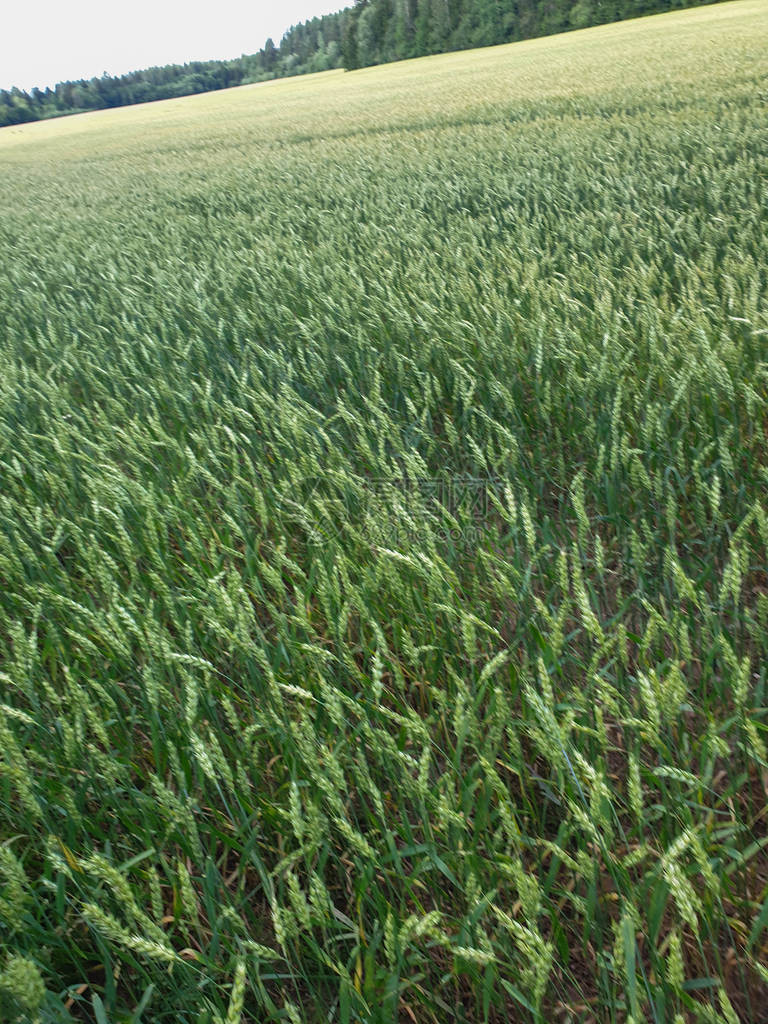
[0,0,351,89]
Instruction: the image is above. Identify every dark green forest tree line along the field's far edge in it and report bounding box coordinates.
[0,0,711,128]
